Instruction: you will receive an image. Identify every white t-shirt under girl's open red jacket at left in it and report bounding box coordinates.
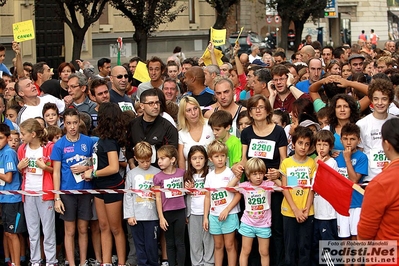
[25,145,43,191]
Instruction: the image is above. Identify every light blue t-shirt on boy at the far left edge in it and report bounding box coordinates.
[0,145,22,203]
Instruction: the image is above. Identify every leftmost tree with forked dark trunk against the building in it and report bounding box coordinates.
[49,0,108,62]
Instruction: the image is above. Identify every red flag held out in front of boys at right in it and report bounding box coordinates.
[313,160,354,216]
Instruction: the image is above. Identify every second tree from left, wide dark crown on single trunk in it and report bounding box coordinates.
[111,0,186,59]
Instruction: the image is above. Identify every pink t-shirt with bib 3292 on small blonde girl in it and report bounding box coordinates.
[239,180,274,227]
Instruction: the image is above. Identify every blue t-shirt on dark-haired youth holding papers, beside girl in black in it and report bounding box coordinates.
[50,134,95,190]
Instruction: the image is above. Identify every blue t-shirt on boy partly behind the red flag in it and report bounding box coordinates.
[335,150,368,208]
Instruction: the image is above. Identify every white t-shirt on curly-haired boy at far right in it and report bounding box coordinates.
[356,114,394,181]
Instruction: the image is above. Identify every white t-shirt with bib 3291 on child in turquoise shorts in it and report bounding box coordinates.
[205,167,240,216]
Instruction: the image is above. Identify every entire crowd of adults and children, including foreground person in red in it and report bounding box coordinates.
[0,35,399,266]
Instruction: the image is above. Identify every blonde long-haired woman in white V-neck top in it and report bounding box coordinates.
[177,96,214,169]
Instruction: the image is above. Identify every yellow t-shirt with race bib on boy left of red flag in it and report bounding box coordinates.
[280,157,316,217]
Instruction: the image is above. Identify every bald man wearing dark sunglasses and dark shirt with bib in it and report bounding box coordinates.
[109,66,136,112]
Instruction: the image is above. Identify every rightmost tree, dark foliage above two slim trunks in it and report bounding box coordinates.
[259,0,327,48]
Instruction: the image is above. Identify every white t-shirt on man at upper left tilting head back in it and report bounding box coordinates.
[17,94,65,125]
